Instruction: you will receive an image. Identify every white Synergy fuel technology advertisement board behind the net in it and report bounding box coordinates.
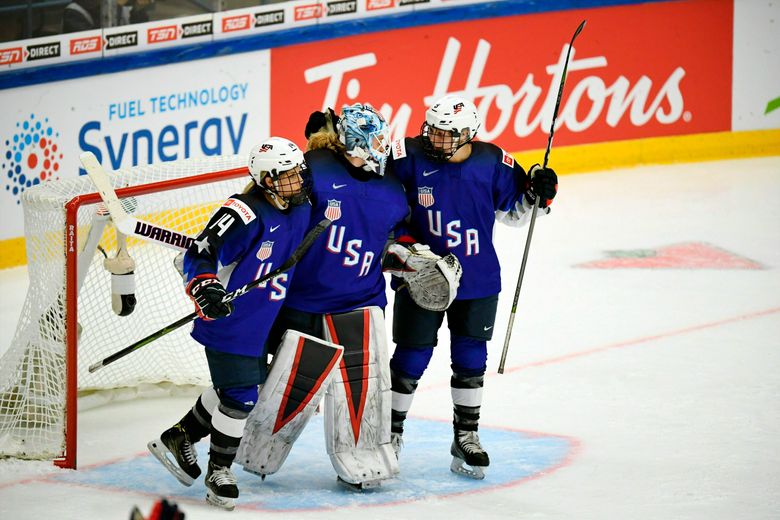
[0,51,269,240]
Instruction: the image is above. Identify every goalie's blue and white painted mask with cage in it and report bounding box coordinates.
[338,103,390,175]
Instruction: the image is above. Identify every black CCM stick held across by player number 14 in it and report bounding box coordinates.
[89,219,331,373]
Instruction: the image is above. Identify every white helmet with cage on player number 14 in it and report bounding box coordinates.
[248,137,312,209]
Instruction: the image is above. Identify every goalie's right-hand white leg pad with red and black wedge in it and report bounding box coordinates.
[325,307,399,488]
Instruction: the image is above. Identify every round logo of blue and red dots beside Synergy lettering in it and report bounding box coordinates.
[0,114,62,204]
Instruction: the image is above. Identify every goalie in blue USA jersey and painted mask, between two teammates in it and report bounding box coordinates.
[239,103,464,488]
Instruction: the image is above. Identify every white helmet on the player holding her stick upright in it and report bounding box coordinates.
[420,94,482,161]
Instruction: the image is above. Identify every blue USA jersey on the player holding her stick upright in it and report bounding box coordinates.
[392,138,527,300]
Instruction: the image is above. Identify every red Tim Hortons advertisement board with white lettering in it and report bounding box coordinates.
[271,0,733,152]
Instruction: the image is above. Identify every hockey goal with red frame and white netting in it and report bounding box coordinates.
[0,156,250,468]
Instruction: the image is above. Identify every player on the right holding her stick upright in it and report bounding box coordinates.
[390,95,558,479]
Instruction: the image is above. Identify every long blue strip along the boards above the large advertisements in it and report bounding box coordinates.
[0,0,672,90]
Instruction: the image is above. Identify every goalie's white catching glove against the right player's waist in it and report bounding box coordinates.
[382,242,463,311]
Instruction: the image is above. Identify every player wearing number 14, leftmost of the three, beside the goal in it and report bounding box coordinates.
[148,137,311,509]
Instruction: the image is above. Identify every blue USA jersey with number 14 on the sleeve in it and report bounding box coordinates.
[184,188,310,357]
